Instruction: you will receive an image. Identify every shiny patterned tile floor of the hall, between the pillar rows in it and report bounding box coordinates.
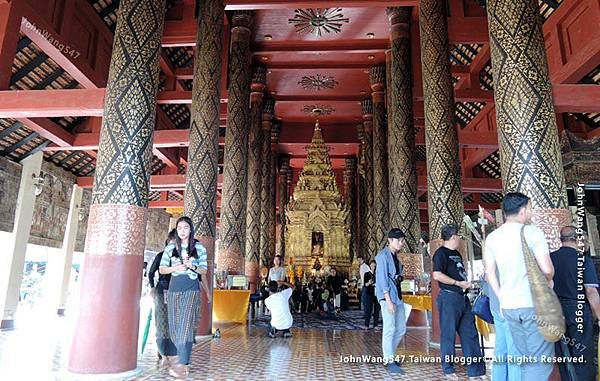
[140,326,492,381]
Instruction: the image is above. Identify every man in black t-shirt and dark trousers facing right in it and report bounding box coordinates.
[433,224,485,380]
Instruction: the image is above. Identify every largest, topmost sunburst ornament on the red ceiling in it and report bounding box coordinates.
[288,8,350,37]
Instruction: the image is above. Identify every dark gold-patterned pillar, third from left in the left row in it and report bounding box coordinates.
[217,11,252,274]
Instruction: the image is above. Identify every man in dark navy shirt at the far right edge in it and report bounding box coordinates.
[550,226,600,380]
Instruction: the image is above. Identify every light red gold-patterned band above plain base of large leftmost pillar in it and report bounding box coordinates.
[85,204,148,256]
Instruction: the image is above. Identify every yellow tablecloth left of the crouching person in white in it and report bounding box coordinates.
[213,290,250,323]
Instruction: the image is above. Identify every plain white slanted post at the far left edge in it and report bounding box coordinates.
[0,152,44,329]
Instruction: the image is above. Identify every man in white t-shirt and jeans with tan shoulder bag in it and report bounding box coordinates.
[485,192,554,380]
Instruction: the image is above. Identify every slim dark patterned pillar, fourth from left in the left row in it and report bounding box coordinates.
[245,65,267,291]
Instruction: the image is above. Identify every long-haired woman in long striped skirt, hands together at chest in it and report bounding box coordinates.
[159,217,208,377]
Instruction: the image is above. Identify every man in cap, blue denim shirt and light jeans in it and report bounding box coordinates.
[375,228,406,374]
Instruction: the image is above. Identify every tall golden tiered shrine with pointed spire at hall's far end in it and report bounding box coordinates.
[285,120,351,272]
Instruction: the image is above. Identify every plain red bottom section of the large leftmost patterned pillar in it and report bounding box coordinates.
[68,254,144,374]
